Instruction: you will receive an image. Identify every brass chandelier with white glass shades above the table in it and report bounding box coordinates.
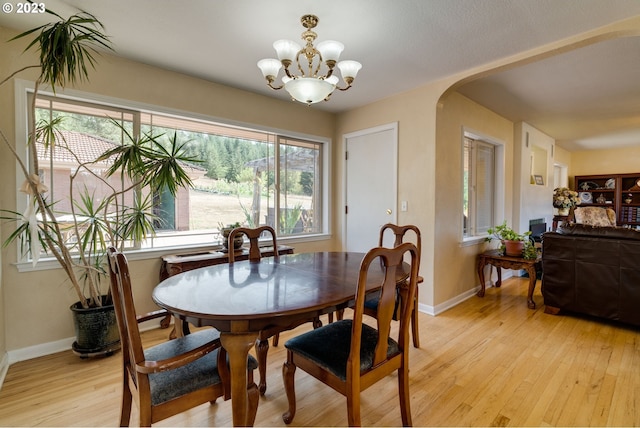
[258,15,362,105]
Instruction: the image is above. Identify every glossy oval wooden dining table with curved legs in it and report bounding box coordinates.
[153,252,408,426]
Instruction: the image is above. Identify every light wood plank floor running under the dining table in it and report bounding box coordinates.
[0,278,640,426]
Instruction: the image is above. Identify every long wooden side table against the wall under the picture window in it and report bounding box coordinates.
[160,245,293,281]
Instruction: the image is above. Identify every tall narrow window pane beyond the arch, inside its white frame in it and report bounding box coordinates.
[463,136,496,237]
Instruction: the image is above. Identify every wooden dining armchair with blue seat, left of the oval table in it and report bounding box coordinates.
[109,247,259,426]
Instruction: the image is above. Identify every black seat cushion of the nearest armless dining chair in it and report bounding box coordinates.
[284,320,400,380]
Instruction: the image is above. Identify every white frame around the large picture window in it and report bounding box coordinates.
[14,79,332,272]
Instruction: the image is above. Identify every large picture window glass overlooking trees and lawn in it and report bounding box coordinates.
[27,90,327,254]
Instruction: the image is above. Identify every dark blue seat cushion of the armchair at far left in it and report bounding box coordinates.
[144,329,258,406]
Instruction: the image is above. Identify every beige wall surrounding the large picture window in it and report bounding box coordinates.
[0,27,336,355]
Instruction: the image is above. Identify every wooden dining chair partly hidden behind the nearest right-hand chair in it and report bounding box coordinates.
[364,223,424,348]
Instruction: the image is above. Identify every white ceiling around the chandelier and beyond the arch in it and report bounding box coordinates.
[0,0,640,150]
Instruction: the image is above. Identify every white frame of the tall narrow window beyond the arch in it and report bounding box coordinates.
[460,127,506,246]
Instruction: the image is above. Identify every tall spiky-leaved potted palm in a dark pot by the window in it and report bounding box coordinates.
[0,6,197,356]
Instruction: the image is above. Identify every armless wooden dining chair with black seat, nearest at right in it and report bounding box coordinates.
[282,243,419,426]
